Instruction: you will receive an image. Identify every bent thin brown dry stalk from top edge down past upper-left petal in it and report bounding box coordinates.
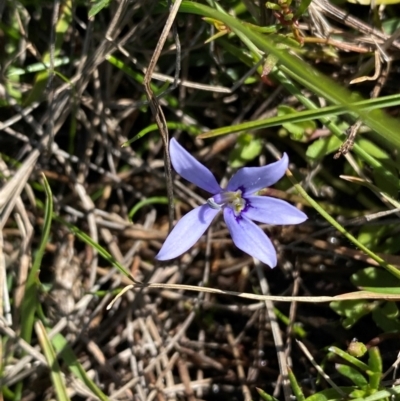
[143,0,182,230]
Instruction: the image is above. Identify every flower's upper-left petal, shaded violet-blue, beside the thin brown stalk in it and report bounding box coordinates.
[169,138,221,194]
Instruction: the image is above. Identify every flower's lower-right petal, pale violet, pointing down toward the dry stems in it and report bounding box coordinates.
[224,208,277,267]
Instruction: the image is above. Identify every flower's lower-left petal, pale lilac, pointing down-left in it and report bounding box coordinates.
[156,205,219,260]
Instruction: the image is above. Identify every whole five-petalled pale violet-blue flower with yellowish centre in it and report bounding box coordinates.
[156,139,307,267]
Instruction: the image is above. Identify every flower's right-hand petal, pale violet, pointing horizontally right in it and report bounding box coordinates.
[242,196,307,224]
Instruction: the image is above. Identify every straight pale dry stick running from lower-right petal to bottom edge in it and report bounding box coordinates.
[254,259,292,401]
